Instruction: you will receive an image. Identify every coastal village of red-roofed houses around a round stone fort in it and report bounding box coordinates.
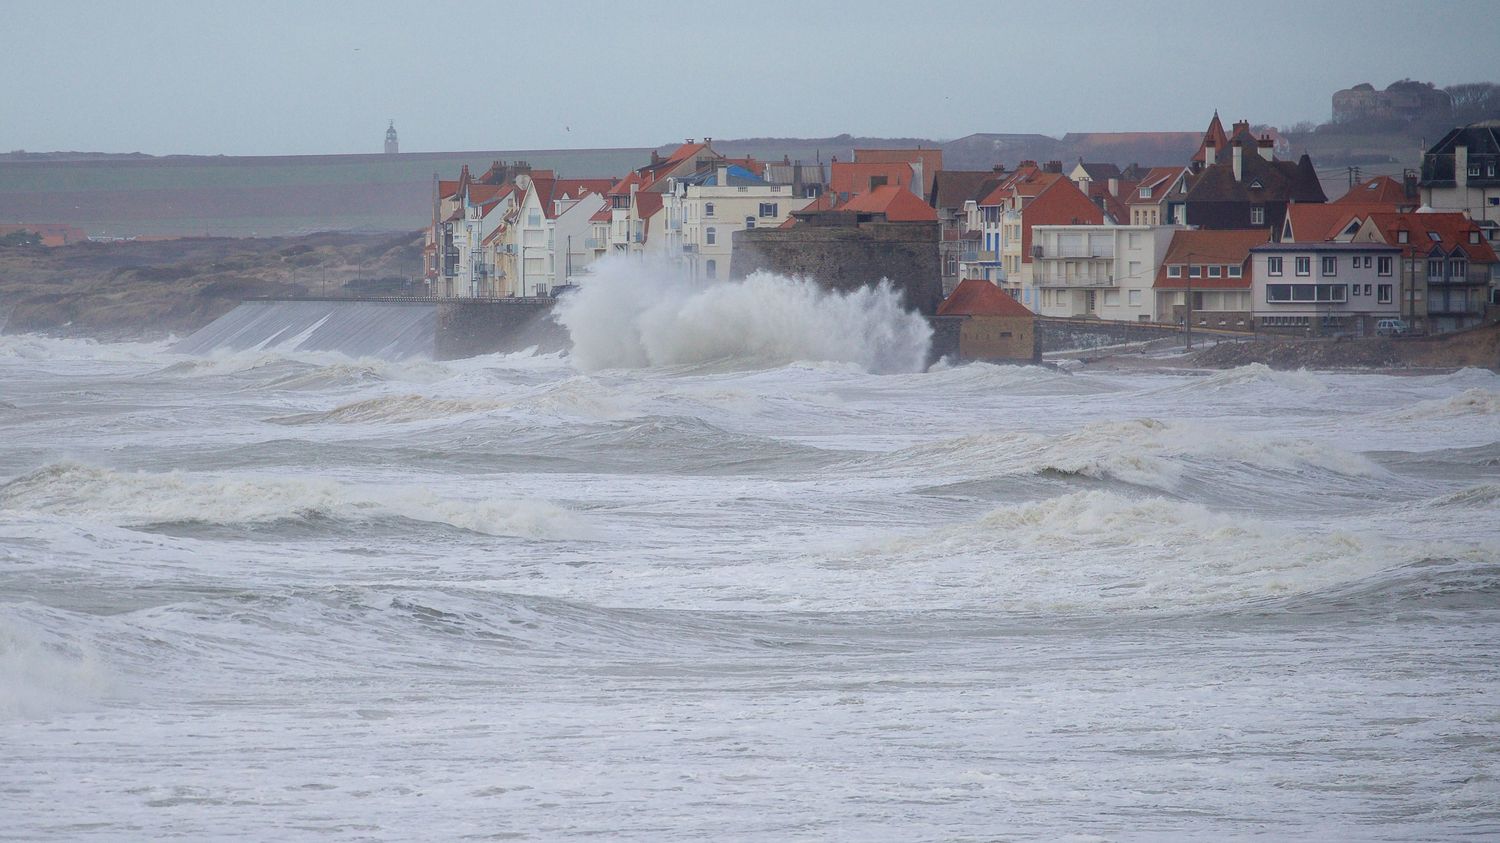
[423,114,1500,360]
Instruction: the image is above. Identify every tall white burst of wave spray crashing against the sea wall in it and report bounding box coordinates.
[557,260,932,374]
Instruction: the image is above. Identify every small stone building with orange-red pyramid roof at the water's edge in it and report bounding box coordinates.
[933,279,1041,363]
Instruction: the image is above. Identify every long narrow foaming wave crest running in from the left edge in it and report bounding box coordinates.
[0,462,587,539]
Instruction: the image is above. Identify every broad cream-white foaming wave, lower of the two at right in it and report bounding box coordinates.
[827,491,1440,612]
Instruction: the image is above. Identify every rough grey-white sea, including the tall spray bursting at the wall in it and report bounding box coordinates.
[0,276,1500,842]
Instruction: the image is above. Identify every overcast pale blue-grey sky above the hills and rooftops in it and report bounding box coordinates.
[0,0,1500,155]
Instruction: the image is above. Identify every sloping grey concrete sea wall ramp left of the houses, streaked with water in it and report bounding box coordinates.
[173,302,438,360]
